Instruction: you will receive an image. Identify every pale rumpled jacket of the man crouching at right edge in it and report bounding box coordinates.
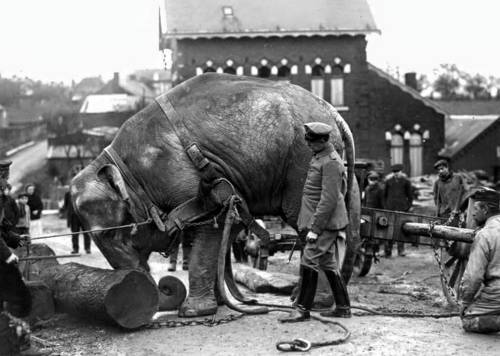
[461,214,500,312]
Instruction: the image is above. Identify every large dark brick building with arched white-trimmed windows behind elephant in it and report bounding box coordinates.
[160,0,446,175]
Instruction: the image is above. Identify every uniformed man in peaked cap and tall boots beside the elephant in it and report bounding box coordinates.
[280,122,351,323]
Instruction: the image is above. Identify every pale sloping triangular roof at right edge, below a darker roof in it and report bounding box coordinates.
[439,115,500,158]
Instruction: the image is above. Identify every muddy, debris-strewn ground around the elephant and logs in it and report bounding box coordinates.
[27,215,500,356]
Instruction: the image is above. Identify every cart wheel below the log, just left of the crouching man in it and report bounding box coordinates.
[441,249,467,306]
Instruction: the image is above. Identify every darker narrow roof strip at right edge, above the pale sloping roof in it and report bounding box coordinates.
[434,100,500,116]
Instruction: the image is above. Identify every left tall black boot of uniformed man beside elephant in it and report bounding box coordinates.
[279,266,318,323]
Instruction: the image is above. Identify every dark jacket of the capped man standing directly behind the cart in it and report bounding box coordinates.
[384,173,413,211]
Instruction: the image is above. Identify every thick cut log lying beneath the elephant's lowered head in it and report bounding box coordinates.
[40,263,159,329]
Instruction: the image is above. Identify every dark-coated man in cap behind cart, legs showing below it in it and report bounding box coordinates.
[384,164,413,257]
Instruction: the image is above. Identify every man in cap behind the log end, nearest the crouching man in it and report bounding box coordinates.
[433,159,465,219]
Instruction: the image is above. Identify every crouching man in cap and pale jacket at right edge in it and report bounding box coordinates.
[460,188,500,333]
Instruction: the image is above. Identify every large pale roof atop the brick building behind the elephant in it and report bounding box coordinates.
[160,0,380,42]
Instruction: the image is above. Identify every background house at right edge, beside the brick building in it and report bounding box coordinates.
[436,100,500,181]
